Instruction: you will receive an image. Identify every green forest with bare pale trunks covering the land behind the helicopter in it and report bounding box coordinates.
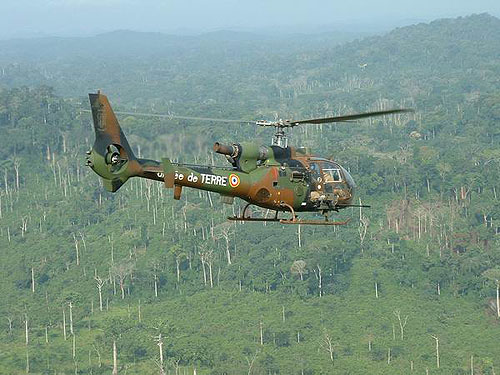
[0,15,500,375]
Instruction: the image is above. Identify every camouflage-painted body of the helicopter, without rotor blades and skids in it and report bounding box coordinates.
[87,92,354,212]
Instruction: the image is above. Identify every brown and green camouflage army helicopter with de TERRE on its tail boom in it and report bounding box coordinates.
[87,91,411,225]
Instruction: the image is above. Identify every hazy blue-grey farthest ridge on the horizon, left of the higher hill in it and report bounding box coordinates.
[0,26,363,62]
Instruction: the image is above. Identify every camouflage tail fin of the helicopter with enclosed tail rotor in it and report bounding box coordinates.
[87,91,144,192]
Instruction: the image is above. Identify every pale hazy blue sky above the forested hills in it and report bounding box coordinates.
[0,0,500,38]
